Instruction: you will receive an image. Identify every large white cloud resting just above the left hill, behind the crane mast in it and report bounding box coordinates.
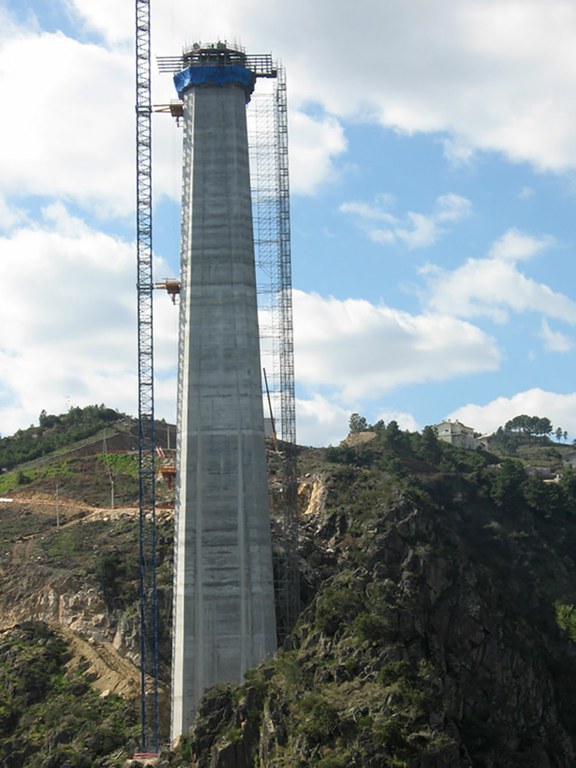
[0,205,176,434]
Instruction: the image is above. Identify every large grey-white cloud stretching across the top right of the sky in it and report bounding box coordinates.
[31,0,576,181]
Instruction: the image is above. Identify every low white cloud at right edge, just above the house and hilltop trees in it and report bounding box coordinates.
[448,388,576,435]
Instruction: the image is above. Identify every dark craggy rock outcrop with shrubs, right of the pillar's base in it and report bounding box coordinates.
[180,470,576,768]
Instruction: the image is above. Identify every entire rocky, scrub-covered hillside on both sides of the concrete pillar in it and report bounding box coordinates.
[0,408,576,768]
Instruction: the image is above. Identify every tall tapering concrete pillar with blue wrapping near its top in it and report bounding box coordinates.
[172,44,276,738]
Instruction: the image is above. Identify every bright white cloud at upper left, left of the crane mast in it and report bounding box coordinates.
[0,25,135,215]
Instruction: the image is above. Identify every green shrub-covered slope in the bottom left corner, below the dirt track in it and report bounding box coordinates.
[0,622,138,768]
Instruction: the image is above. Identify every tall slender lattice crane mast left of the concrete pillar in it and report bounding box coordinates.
[136,0,158,753]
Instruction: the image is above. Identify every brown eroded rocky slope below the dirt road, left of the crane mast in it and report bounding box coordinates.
[0,504,160,663]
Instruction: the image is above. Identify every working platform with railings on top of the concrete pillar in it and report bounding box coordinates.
[157,42,278,77]
